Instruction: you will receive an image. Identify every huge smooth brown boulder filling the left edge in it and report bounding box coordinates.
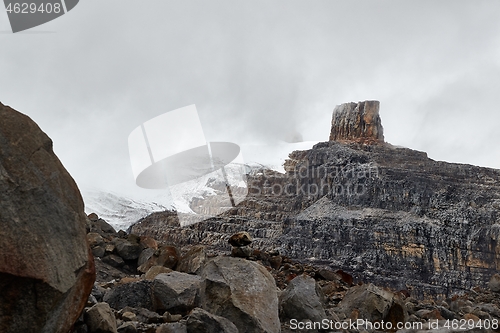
[0,103,95,333]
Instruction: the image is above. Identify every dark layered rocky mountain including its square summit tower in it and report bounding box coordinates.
[131,101,500,297]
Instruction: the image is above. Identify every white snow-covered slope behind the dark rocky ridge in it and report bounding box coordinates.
[81,141,316,230]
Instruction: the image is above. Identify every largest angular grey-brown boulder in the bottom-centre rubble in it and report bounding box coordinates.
[201,257,281,333]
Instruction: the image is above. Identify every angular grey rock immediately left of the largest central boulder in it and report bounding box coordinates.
[153,271,205,314]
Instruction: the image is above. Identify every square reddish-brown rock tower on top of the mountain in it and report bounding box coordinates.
[330,101,384,143]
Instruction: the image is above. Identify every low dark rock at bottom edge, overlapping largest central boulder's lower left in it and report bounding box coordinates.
[187,308,239,333]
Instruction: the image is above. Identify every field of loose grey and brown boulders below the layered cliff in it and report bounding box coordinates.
[80,214,500,333]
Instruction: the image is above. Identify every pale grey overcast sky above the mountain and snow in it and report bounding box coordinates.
[0,0,500,197]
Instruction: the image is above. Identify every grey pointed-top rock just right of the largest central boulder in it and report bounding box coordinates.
[280,275,327,322]
